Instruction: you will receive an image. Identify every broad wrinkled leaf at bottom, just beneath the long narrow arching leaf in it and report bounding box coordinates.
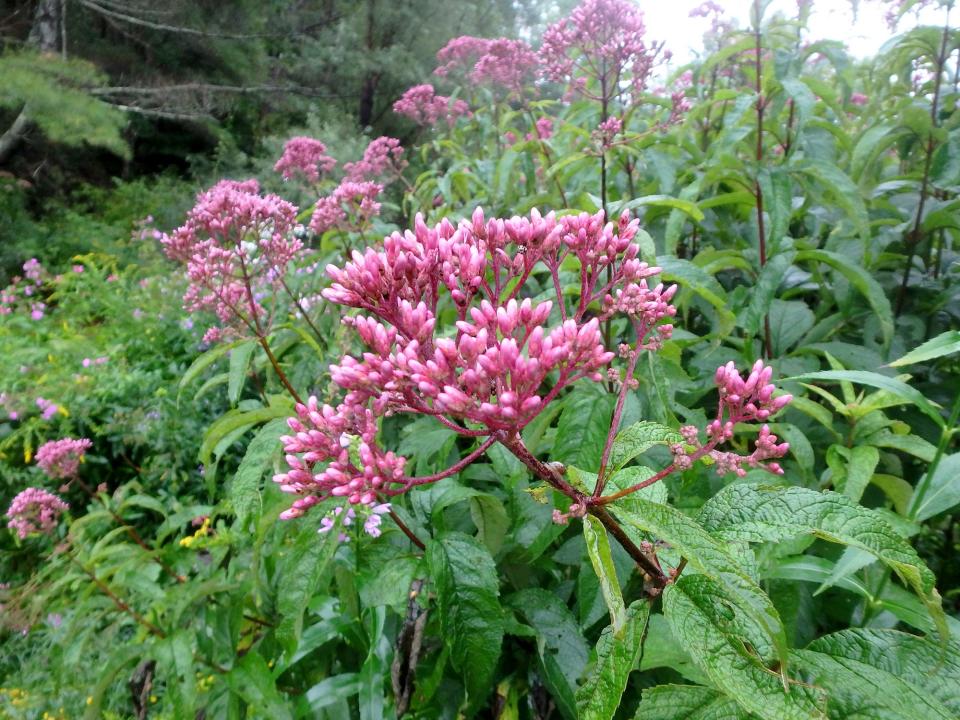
[660,575,826,720]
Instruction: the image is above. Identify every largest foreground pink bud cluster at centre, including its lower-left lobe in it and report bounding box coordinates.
[275,209,675,517]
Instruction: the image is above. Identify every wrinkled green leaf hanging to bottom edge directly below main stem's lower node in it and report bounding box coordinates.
[577,600,650,720]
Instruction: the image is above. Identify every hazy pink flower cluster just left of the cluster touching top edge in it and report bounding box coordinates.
[434,35,538,94]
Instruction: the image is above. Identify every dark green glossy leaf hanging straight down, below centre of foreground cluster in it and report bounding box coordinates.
[426,533,503,706]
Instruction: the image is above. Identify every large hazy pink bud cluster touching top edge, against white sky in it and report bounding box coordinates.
[540,0,659,100]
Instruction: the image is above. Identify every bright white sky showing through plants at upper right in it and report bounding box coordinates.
[639,0,943,64]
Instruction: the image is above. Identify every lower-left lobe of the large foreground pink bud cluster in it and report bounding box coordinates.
[273,397,406,510]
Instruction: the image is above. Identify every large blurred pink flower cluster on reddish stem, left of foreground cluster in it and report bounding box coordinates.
[161,180,302,340]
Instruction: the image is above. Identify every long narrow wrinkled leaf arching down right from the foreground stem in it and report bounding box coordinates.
[610,498,787,666]
